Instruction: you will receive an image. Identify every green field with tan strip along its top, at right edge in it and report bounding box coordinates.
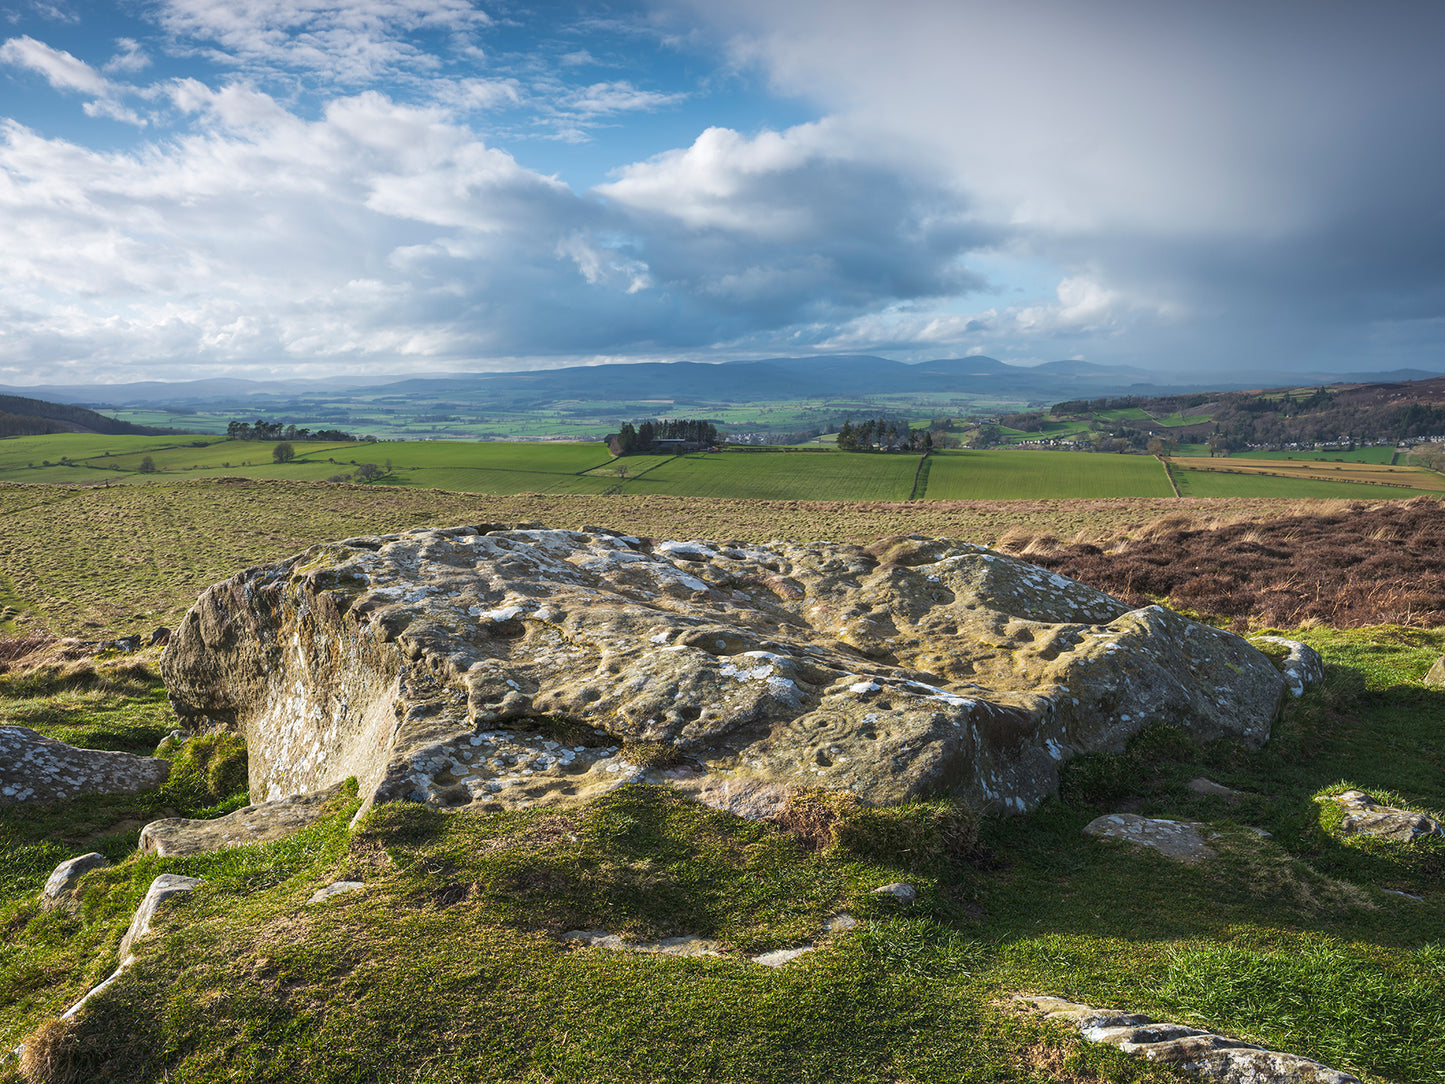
[1170,457,1445,499]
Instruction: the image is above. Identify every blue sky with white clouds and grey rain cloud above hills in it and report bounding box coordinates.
[0,0,1445,384]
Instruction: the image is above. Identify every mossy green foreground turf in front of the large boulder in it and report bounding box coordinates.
[0,627,1445,1084]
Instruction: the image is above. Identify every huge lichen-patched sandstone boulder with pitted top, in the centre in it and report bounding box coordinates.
[162,525,1285,811]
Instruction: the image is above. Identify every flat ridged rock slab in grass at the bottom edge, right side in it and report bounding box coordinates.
[1014,996,1360,1084]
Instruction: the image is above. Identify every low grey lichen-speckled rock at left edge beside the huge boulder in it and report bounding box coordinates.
[0,727,171,805]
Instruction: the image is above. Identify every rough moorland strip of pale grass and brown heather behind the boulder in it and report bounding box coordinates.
[0,478,1445,637]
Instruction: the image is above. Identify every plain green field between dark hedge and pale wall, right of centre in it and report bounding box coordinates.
[922,451,1173,500]
